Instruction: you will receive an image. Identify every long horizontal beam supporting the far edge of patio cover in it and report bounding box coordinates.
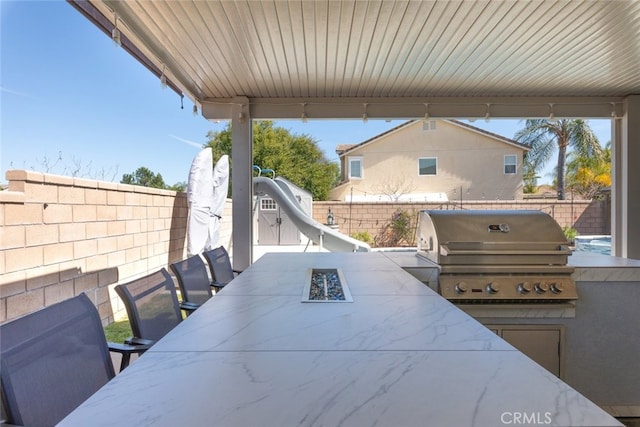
[202,97,624,120]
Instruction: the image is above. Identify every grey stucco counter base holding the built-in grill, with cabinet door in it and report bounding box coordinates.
[384,250,640,418]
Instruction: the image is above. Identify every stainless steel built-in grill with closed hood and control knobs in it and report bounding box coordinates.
[418,210,578,304]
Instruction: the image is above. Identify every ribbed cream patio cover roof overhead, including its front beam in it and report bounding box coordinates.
[69,0,640,119]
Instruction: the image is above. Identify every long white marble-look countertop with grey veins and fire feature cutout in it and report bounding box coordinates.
[60,253,621,427]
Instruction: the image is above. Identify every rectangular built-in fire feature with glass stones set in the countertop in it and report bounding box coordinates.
[302,268,353,302]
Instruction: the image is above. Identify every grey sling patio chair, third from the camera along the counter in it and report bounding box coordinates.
[170,255,213,307]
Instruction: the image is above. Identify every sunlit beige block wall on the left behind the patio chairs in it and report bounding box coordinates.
[0,170,231,324]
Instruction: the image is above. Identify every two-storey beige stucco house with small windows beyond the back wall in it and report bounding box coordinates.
[330,120,529,201]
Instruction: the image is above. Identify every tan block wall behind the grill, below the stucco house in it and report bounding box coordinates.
[313,199,611,244]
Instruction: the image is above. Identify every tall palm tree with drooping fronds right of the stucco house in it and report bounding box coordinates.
[514,119,602,200]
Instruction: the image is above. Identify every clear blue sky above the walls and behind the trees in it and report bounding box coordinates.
[0,0,611,184]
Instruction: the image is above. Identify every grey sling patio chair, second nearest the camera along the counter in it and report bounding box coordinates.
[115,268,196,345]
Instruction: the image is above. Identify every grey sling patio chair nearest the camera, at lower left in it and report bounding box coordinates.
[0,294,148,427]
